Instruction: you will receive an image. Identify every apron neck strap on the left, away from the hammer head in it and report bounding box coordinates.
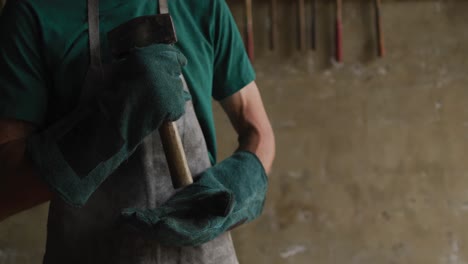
[88,0,101,67]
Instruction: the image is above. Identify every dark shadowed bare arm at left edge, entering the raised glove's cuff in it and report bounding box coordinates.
[0,119,52,222]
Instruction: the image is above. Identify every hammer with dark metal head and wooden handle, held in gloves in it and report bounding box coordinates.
[107,14,193,189]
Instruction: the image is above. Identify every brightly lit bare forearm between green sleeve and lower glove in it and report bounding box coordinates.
[220,82,275,173]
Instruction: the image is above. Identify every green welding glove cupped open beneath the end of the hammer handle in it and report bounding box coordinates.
[122,151,268,247]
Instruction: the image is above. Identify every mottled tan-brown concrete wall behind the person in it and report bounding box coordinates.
[0,0,468,264]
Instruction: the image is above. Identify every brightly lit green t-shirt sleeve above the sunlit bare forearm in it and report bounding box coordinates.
[212,0,255,100]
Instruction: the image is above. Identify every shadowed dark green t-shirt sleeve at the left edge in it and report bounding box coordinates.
[0,0,47,125]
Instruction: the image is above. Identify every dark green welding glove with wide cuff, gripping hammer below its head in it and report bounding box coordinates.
[27,44,187,206]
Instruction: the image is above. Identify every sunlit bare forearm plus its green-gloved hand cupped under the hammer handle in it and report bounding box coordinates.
[122,83,275,246]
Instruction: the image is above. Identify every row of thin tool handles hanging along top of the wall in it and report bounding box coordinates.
[241,0,385,63]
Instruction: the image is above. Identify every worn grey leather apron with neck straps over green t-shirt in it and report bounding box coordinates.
[44,0,238,264]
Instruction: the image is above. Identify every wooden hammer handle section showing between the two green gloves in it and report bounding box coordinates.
[159,122,193,189]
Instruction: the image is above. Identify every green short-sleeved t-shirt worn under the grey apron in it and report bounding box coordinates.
[0,0,255,163]
